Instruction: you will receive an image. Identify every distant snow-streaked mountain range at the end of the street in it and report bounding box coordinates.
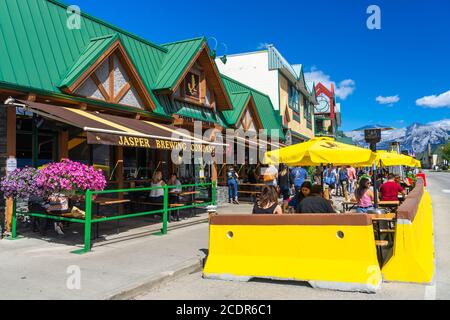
[345,119,450,153]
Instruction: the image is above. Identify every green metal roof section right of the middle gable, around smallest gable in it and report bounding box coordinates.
[221,75,285,140]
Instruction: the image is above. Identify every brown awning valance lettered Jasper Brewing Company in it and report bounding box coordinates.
[87,132,215,153]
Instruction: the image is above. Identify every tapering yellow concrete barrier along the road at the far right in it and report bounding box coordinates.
[382,180,435,283]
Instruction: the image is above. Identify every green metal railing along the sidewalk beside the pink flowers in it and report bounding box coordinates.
[11,182,217,254]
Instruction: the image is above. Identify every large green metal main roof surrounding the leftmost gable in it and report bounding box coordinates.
[0,0,167,92]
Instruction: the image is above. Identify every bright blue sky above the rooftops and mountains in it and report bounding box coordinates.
[71,0,450,131]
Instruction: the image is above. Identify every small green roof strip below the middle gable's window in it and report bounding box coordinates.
[158,95,227,128]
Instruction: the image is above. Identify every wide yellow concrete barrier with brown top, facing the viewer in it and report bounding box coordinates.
[203,214,382,292]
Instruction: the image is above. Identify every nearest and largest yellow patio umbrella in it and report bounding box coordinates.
[265,138,376,166]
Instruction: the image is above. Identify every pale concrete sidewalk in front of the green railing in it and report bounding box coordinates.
[0,204,251,300]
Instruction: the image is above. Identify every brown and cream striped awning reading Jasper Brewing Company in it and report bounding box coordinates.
[13,100,226,153]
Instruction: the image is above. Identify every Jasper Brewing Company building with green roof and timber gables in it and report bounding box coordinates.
[0,0,284,228]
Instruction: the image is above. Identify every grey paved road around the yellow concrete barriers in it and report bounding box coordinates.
[138,173,450,300]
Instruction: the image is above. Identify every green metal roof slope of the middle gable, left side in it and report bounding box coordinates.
[154,38,206,90]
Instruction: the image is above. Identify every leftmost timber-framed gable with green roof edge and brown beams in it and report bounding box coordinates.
[60,35,155,110]
